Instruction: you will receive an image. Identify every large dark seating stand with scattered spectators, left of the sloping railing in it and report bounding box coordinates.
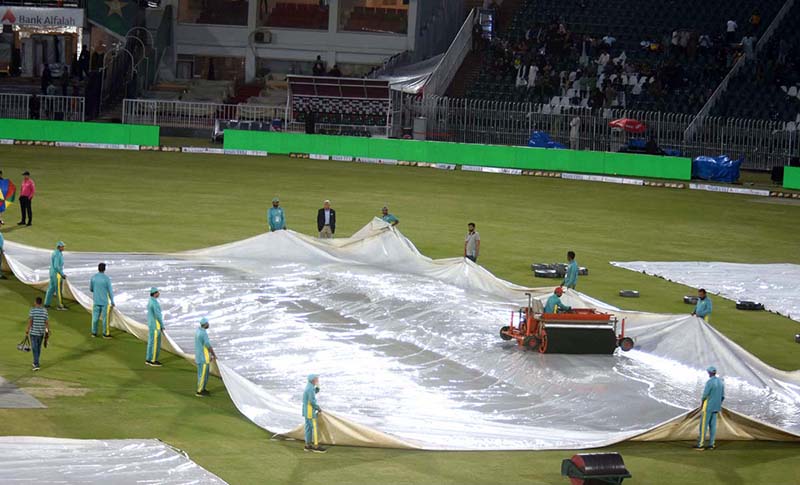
[467,0,782,113]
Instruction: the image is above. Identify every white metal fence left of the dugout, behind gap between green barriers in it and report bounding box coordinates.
[122,99,286,133]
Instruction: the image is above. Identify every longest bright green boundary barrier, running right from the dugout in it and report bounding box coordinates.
[225,130,692,180]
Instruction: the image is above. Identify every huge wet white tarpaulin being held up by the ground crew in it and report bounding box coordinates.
[6,219,800,450]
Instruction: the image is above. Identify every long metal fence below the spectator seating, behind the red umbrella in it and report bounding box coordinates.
[412,96,800,170]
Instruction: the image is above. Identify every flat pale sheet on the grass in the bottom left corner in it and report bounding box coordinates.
[0,436,225,485]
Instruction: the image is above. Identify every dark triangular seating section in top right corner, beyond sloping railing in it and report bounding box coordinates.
[711,3,800,121]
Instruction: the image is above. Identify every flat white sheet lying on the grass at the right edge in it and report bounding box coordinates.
[611,261,800,322]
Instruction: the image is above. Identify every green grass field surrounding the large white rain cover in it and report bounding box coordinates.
[0,146,800,485]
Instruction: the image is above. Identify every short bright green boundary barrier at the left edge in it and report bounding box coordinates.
[0,119,159,146]
